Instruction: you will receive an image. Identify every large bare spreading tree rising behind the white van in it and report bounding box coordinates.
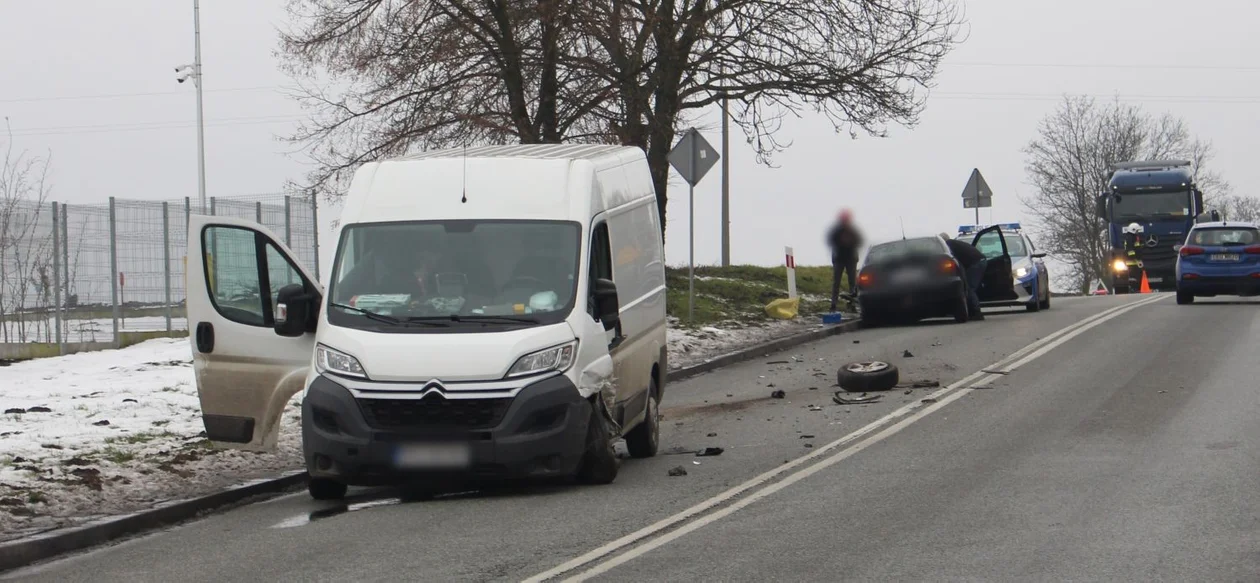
[281,0,961,232]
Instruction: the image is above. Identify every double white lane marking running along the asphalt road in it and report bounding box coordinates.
[524,296,1164,583]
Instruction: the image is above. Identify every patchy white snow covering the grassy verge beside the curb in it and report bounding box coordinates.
[0,319,851,540]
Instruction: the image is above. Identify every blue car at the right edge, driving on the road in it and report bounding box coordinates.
[1177,220,1260,305]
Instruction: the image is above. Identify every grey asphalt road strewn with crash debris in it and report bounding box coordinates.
[9,295,1260,582]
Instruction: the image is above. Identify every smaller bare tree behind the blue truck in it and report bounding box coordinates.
[1023,97,1230,292]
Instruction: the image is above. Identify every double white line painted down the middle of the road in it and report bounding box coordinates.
[525,295,1168,583]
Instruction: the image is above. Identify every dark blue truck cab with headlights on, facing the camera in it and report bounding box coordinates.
[1095,160,1205,293]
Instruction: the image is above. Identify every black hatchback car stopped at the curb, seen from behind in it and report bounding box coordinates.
[858,237,968,326]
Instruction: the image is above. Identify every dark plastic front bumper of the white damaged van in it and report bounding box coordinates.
[302,375,591,486]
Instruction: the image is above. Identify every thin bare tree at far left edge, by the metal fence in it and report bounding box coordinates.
[0,124,52,342]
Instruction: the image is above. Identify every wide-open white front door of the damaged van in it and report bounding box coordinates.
[186,215,323,451]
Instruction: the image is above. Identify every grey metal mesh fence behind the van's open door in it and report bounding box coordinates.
[0,195,319,346]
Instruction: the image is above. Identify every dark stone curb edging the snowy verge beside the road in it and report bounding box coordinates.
[0,320,861,573]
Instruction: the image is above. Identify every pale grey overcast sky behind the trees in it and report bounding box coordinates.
[0,0,1260,272]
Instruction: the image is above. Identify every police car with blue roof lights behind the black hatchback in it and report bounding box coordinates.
[958,223,1050,312]
